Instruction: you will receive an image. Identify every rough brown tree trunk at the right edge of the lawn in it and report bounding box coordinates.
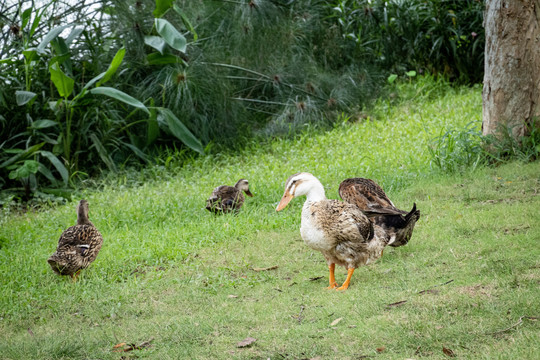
[482,0,540,138]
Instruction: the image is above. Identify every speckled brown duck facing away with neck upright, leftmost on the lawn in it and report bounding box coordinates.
[47,200,103,280]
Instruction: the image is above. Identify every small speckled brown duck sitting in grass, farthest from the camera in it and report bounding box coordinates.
[206,179,253,214]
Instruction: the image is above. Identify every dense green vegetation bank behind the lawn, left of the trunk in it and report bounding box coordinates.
[0,0,484,204]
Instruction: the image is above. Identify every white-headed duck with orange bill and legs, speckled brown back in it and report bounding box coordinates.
[276,172,389,290]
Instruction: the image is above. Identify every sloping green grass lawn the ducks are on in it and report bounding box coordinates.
[0,83,540,359]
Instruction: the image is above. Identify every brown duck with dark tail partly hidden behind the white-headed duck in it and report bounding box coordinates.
[339,178,420,247]
